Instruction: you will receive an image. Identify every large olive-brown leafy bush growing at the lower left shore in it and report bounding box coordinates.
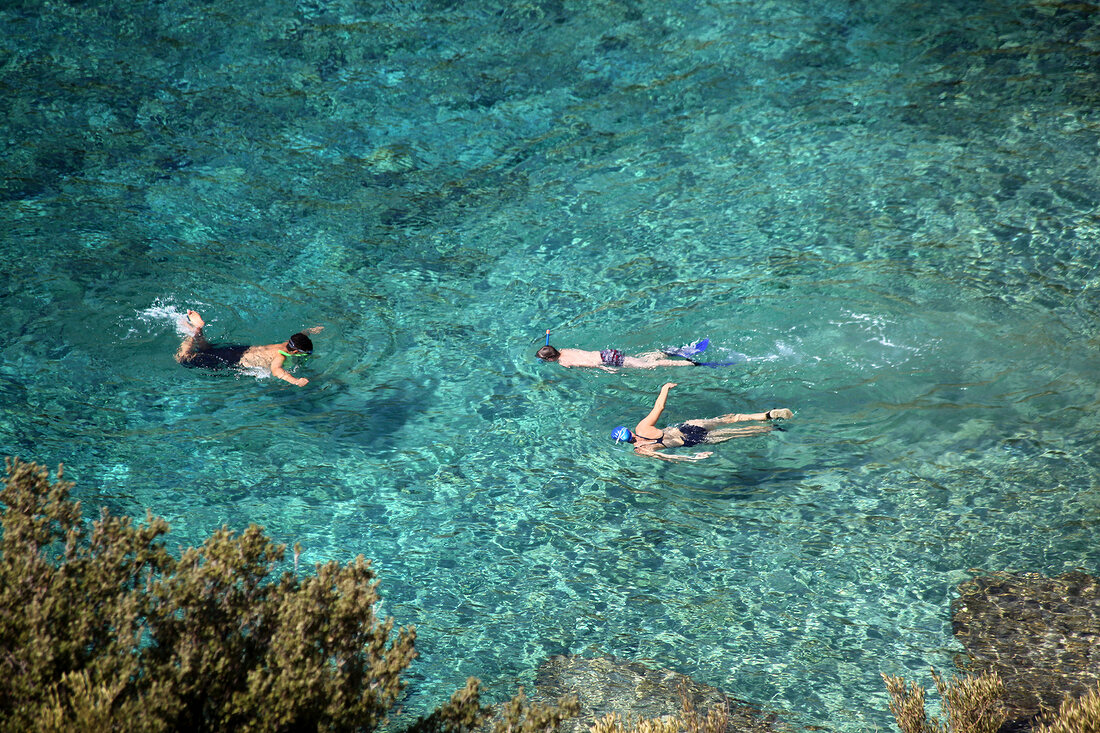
[0,460,575,733]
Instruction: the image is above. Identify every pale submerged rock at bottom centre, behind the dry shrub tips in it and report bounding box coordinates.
[531,655,791,733]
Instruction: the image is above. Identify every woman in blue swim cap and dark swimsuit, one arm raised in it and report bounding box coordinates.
[612,382,794,461]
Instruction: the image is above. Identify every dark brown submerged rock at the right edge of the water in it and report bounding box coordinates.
[952,572,1100,729]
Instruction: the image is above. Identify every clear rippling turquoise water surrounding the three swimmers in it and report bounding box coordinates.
[0,1,1100,731]
